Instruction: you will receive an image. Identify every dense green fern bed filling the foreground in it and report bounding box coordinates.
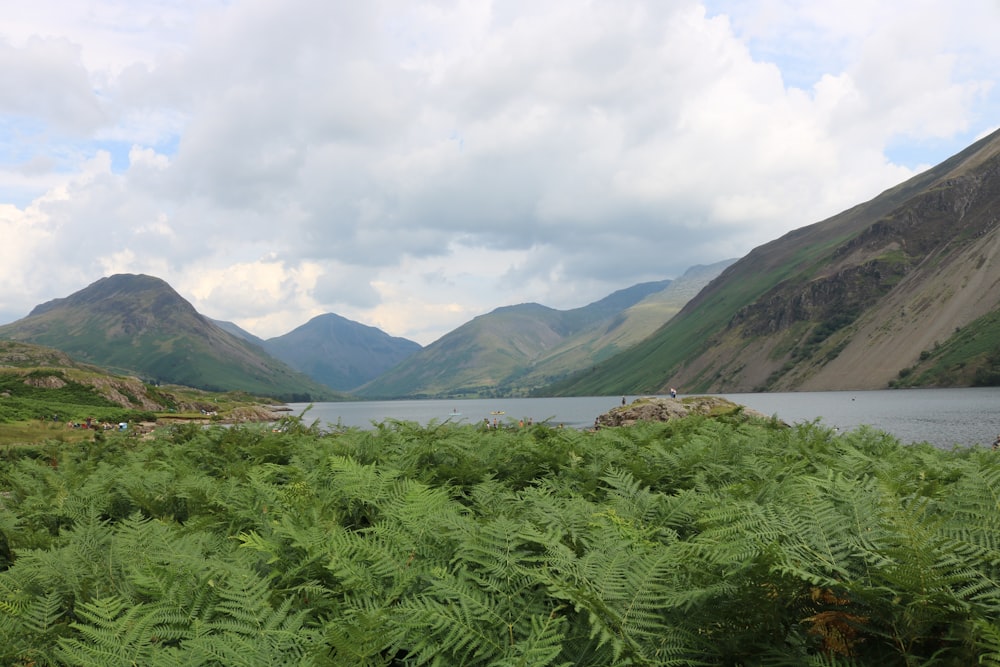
[0,410,1000,667]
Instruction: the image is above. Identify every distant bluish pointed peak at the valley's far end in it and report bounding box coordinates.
[261,313,421,391]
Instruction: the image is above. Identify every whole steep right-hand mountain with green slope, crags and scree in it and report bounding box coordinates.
[548,131,1000,395]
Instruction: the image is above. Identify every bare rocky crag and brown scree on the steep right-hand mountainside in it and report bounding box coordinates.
[669,149,1000,392]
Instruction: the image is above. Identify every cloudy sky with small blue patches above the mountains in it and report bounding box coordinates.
[0,0,1000,344]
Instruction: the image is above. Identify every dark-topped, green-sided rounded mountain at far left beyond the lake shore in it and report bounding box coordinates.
[0,274,336,400]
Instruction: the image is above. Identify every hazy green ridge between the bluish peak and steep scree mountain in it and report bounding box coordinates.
[355,263,726,398]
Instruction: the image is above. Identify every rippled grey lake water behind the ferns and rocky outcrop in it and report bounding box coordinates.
[289,387,1000,447]
